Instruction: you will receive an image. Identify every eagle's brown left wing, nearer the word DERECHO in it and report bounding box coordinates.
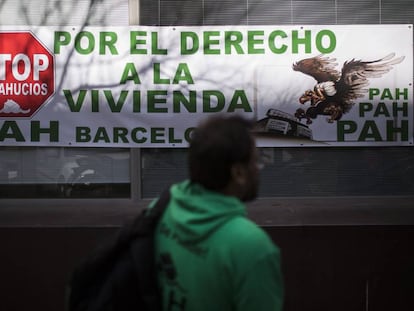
[292,55,341,83]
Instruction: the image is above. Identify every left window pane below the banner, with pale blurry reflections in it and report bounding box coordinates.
[0,147,131,198]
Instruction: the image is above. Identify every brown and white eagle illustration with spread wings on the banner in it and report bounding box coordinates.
[292,53,404,124]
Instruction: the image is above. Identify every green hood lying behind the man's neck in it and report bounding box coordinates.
[163,180,246,243]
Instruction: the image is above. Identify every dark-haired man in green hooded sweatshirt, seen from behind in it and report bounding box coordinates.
[155,115,283,311]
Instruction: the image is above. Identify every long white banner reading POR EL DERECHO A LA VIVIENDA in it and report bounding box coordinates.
[0,25,414,147]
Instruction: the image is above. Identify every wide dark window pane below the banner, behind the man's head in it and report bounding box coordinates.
[142,147,414,198]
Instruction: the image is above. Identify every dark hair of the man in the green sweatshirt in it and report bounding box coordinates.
[189,115,255,191]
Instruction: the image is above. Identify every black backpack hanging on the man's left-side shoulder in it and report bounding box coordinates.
[66,190,170,311]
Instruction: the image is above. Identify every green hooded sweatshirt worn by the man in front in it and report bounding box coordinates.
[155,181,283,311]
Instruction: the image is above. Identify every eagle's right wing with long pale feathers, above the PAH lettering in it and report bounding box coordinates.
[336,53,404,111]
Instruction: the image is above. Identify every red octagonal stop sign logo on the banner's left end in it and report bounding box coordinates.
[0,32,55,118]
